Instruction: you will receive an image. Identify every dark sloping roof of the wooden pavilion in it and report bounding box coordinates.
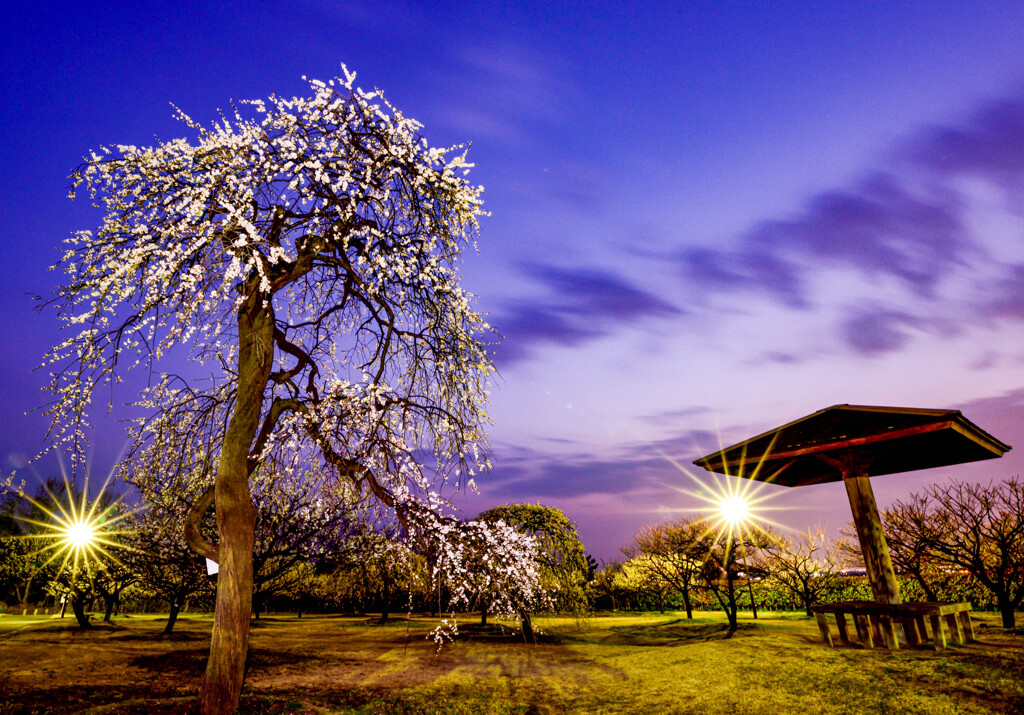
[693,405,1011,487]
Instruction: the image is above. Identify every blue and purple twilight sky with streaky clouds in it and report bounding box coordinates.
[0,0,1024,559]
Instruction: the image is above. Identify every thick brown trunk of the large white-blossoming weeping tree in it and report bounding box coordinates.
[199,292,273,715]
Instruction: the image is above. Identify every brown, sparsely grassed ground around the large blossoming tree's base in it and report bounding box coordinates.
[0,616,561,714]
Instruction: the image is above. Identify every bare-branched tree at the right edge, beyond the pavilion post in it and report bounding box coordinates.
[891,477,1024,628]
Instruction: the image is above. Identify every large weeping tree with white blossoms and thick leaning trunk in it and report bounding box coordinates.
[47,69,534,713]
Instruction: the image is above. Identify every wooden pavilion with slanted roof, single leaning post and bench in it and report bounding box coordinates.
[694,405,1011,647]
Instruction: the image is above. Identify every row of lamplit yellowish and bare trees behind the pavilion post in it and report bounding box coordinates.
[591,477,1024,629]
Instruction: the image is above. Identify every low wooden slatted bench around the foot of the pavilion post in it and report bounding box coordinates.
[811,601,975,650]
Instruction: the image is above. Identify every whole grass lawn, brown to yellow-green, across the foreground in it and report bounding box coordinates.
[0,614,1024,715]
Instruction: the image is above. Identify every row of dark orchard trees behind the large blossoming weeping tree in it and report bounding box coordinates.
[0,470,590,638]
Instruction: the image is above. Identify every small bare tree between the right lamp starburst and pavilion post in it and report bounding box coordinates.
[763,529,843,616]
